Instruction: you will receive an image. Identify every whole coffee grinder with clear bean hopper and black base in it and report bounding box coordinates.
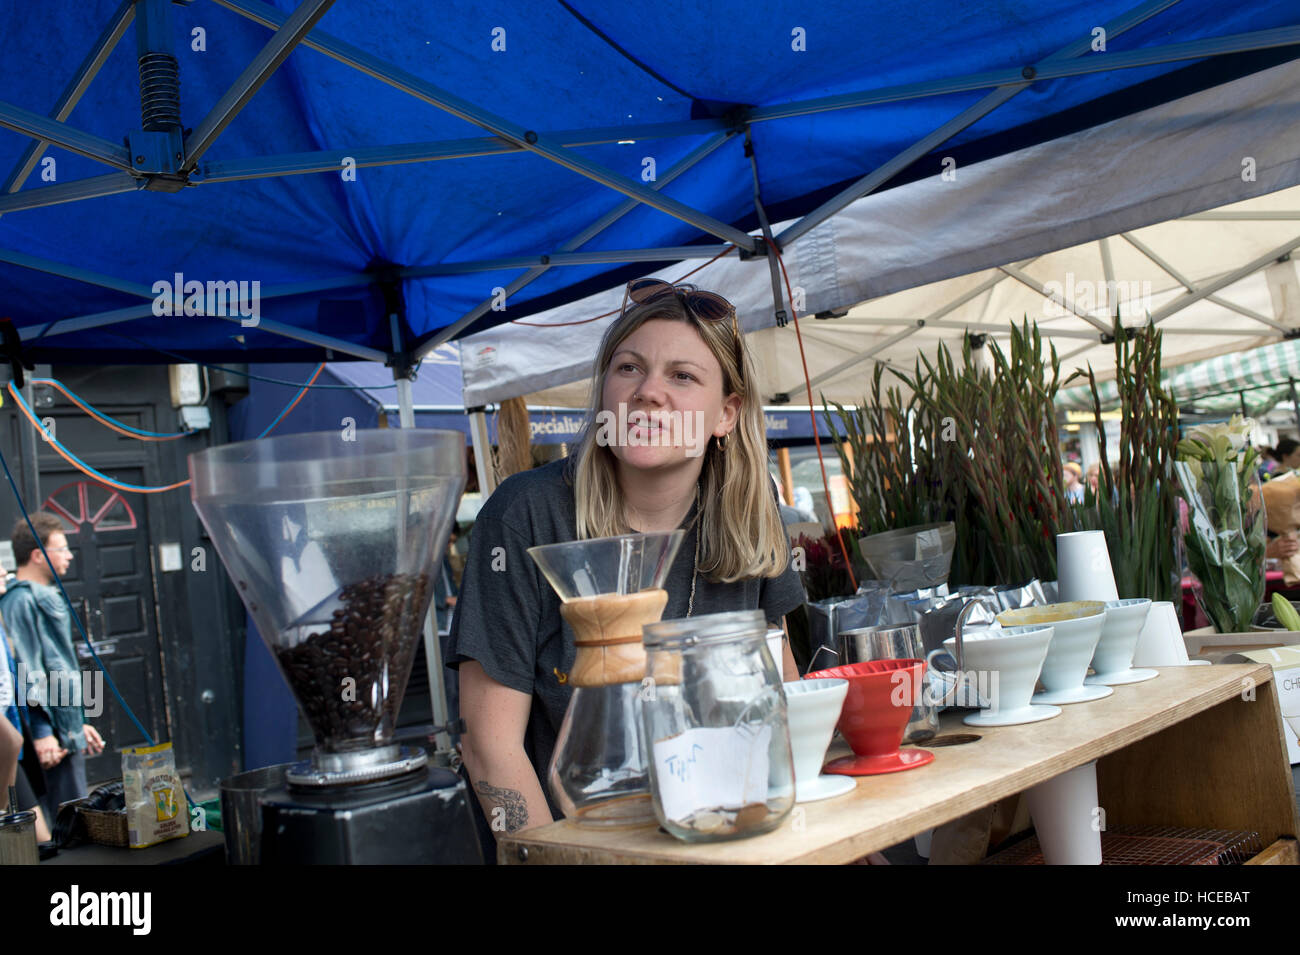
[190,430,482,864]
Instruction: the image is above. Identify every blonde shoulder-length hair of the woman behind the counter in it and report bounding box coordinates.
[573,289,789,582]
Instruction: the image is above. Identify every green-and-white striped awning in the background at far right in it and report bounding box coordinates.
[1056,340,1300,414]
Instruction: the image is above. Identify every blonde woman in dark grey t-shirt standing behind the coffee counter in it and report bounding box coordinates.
[447,279,803,847]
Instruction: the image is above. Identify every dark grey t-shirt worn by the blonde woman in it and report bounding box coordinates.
[447,459,803,819]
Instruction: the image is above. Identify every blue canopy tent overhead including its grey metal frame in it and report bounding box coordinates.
[0,0,1300,769]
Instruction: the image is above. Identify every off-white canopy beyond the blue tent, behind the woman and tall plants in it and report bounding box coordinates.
[462,55,1300,407]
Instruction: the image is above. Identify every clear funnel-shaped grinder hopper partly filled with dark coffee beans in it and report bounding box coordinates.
[190,430,465,785]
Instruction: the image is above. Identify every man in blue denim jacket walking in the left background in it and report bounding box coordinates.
[0,511,104,819]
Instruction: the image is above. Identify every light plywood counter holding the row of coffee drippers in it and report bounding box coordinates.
[498,664,1300,865]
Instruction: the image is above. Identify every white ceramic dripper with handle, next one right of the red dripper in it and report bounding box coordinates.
[944,625,1061,726]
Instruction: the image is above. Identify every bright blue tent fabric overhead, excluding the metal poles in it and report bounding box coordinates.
[0,0,1300,364]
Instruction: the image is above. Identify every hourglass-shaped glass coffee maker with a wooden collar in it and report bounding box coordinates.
[528,530,684,828]
